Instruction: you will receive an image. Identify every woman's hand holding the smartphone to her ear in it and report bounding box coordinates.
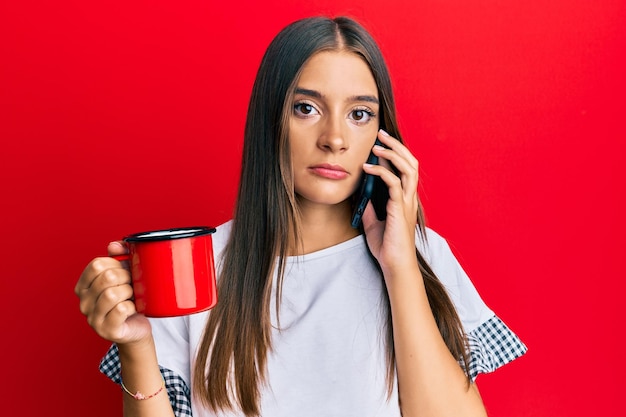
[363,130,418,276]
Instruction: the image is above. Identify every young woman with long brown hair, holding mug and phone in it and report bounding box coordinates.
[76,18,526,417]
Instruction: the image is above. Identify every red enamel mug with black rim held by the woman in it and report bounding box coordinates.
[114,226,217,317]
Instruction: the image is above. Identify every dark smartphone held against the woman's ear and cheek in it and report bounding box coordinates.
[352,139,389,229]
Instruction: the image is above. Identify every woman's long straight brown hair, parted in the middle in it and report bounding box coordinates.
[193,17,468,416]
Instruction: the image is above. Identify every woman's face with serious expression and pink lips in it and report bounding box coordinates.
[289,51,379,210]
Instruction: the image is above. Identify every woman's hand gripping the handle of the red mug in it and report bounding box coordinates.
[74,242,152,344]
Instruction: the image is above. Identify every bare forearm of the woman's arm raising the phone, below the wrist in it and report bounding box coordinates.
[385,264,486,417]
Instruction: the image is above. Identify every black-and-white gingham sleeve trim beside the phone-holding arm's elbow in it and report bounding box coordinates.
[467,316,528,381]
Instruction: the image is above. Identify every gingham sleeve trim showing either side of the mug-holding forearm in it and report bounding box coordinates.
[100,344,192,417]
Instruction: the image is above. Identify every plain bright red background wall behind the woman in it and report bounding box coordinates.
[0,0,626,417]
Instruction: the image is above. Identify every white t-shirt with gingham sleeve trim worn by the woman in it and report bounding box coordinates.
[100,222,526,417]
